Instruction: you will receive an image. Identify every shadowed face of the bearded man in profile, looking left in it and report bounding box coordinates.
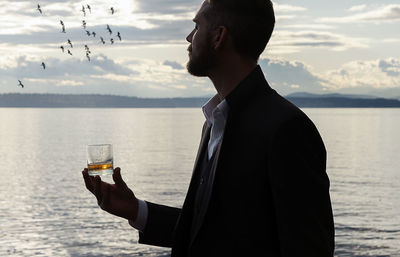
[186,1,216,76]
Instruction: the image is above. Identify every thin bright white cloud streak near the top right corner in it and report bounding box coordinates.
[317,4,400,23]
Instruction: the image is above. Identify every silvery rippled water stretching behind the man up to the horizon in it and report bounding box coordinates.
[0,109,400,256]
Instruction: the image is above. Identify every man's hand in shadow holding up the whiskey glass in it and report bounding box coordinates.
[82,168,139,221]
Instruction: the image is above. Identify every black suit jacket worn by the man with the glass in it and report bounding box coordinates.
[139,66,334,257]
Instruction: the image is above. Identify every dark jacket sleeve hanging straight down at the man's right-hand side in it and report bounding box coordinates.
[268,117,334,254]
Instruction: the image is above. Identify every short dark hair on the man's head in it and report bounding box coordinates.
[204,0,275,61]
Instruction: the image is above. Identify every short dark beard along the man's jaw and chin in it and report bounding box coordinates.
[186,37,216,77]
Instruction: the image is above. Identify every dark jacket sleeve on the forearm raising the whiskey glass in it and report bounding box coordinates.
[139,202,181,247]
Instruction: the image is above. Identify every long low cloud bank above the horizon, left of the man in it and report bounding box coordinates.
[0,55,215,97]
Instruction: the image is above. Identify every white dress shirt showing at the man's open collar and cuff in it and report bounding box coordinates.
[129,94,229,231]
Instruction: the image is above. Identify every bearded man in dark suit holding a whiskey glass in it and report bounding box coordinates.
[83,0,334,254]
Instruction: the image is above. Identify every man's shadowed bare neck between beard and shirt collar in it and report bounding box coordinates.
[208,57,257,100]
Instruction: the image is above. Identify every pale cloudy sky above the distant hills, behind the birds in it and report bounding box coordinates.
[0,0,400,98]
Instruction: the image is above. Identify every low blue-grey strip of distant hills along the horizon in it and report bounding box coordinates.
[0,93,400,108]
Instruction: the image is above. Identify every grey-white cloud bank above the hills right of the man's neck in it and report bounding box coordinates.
[259,58,400,96]
